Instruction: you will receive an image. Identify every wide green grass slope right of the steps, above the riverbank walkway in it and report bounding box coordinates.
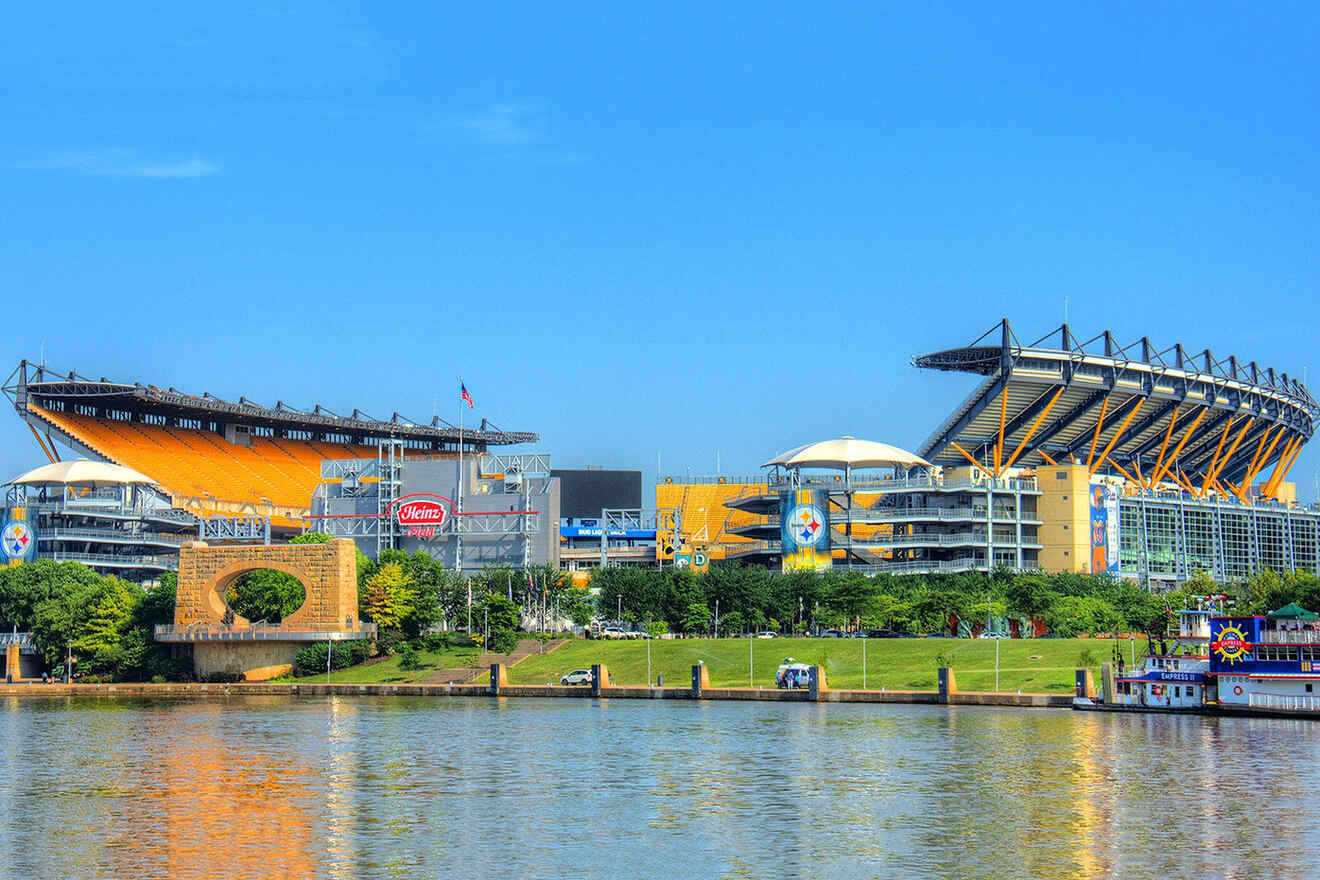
[508,639,1144,694]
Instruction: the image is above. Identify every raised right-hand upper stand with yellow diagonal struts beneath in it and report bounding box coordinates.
[913,318,1320,501]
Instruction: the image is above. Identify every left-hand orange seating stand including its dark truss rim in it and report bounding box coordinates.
[4,360,537,526]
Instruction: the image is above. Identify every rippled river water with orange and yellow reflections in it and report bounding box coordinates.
[0,697,1320,880]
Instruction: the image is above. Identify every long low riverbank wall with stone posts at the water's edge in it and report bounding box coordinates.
[0,665,1073,708]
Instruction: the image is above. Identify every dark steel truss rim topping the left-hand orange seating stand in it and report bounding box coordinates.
[4,360,539,450]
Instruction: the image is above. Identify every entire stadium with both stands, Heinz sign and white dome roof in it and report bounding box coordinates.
[4,321,1320,586]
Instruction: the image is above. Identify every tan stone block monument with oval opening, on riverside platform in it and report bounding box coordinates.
[156,538,376,681]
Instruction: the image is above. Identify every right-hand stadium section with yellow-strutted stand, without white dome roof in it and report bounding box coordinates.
[656,319,1320,586]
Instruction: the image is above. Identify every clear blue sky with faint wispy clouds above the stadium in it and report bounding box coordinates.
[0,0,1320,497]
